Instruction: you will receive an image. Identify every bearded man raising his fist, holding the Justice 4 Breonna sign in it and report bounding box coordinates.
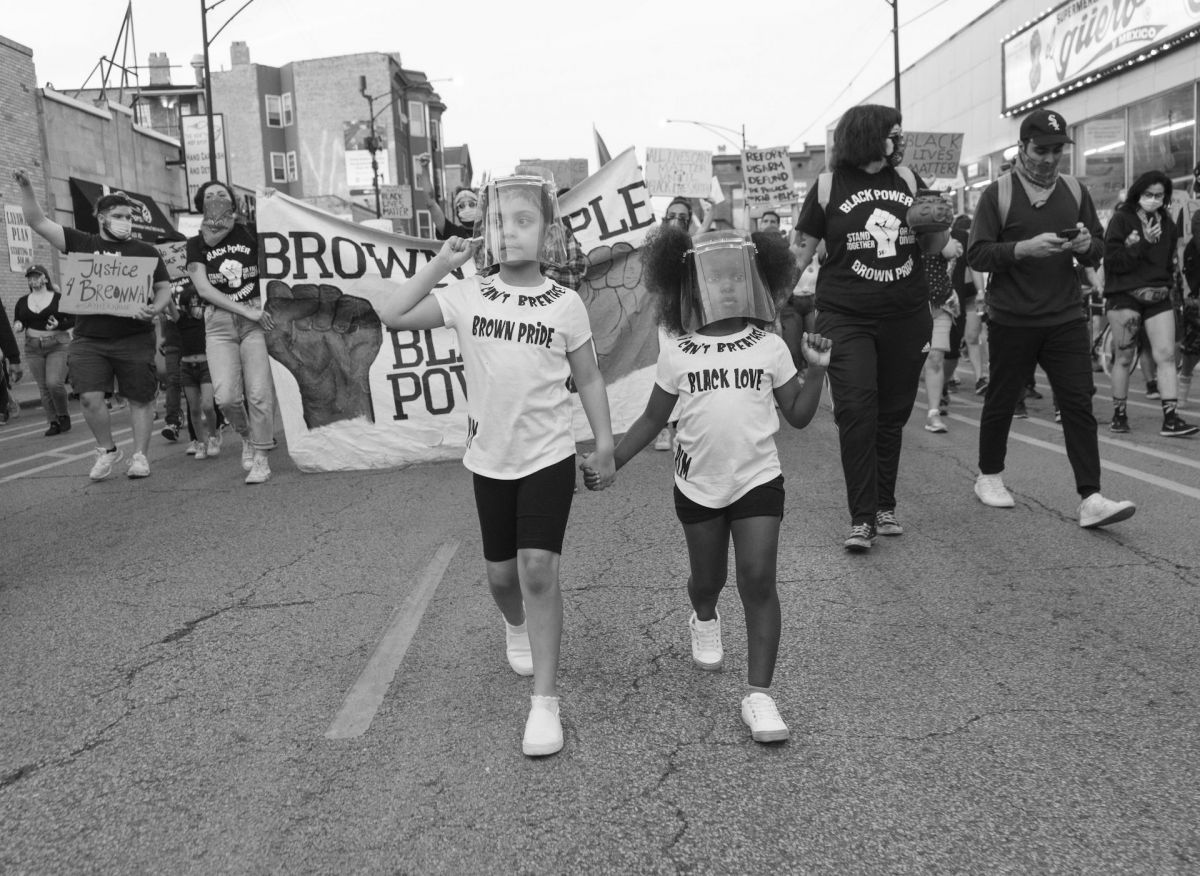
[13,170,170,480]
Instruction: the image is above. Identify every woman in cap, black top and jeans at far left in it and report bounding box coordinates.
[13,265,74,437]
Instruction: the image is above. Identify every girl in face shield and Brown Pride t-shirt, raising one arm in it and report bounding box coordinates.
[360,176,614,756]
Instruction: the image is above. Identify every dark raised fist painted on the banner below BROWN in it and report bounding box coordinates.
[266,280,383,428]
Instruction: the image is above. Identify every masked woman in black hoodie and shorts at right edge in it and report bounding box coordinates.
[1104,170,1200,438]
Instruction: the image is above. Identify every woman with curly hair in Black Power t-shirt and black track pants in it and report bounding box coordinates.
[797,104,948,552]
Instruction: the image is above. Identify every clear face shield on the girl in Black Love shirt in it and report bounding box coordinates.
[679,232,775,331]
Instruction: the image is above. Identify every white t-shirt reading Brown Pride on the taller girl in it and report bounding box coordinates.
[433,276,592,480]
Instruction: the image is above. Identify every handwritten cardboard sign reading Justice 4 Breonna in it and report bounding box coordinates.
[59,252,158,317]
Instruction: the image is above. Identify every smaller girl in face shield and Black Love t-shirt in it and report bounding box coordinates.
[583,226,832,742]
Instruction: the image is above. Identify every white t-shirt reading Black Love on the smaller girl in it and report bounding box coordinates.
[655,325,796,508]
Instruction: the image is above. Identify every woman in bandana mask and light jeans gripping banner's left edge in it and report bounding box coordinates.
[187,180,275,484]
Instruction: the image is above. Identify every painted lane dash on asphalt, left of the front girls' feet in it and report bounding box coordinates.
[325,541,460,739]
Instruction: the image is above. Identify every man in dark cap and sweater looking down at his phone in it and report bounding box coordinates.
[967,102,1136,528]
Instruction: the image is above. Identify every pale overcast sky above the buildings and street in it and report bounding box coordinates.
[0,0,1002,173]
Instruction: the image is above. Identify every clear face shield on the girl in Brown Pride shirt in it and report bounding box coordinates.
[475,176,566,269]
